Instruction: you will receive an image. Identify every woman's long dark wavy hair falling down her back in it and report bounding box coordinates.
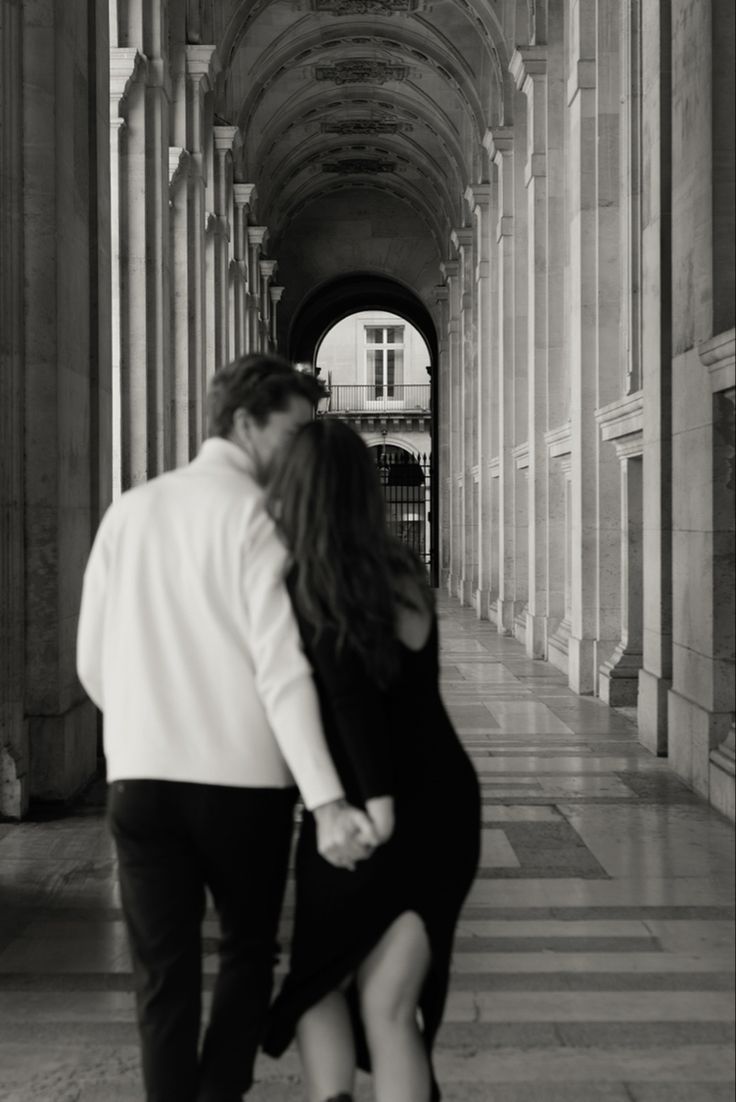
[269,418,430,687]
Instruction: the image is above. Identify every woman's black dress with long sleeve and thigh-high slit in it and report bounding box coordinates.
[263,599,480,1099]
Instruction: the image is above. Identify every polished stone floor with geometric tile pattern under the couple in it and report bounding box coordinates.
[0,601,735,1102]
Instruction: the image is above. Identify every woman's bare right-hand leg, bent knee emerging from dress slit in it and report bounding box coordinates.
[357,911,431,1102]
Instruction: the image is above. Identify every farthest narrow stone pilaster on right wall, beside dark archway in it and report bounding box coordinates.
[441,260,463,596]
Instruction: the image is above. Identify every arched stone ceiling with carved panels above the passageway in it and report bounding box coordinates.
[199,0,522,343]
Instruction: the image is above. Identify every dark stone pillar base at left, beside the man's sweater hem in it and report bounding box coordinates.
[29,701,97,800]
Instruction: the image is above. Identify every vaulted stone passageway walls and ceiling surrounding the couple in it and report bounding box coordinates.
[0,0,736,815]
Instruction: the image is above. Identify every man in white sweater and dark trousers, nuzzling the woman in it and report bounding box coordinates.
[77,356,378,1102]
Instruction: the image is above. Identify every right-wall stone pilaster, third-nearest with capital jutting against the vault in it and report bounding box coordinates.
[465,184,493,617]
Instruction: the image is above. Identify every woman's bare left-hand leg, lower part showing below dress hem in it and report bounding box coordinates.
[296,991,355,1102]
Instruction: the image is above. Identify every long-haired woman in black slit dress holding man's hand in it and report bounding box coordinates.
[264,419,480,1102]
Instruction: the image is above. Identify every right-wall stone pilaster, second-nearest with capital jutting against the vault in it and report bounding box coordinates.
[484,128,517,635]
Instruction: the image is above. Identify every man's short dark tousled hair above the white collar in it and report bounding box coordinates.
[207,354,325,436]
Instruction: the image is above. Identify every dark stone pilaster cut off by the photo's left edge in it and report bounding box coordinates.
[0,3,30,819]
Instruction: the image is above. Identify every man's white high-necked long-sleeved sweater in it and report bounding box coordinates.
[77,437,343,808]
